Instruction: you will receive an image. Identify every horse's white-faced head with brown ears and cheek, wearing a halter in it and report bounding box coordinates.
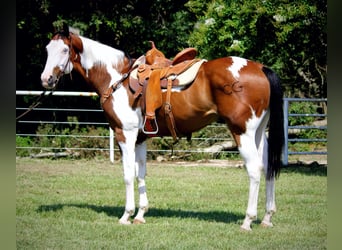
[41,25,73,89]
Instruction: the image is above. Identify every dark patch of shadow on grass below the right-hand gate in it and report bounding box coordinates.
[280,161,328,176]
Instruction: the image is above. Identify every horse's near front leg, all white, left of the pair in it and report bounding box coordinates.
[118,129,138,224]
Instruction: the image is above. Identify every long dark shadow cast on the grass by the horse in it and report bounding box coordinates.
[37,204,244,223]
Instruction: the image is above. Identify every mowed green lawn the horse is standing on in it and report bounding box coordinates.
[16,159,327,250]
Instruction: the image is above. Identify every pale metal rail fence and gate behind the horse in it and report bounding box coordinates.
[16,91,327,164]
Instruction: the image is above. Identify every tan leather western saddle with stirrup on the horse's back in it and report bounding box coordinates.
[129,41,204,141]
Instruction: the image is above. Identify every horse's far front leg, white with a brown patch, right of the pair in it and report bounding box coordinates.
[133,142,148,224]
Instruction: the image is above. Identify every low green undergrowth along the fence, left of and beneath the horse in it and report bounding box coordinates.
[16,121,240,161]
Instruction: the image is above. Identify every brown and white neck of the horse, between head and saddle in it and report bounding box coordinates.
[73,36,129,96]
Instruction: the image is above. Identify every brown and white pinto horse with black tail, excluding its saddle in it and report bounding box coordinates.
[41,27,284,231]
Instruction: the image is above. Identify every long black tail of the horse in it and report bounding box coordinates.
[262,66,285,180]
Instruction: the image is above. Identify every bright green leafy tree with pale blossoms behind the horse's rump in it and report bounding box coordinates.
[186,0,327,97]
